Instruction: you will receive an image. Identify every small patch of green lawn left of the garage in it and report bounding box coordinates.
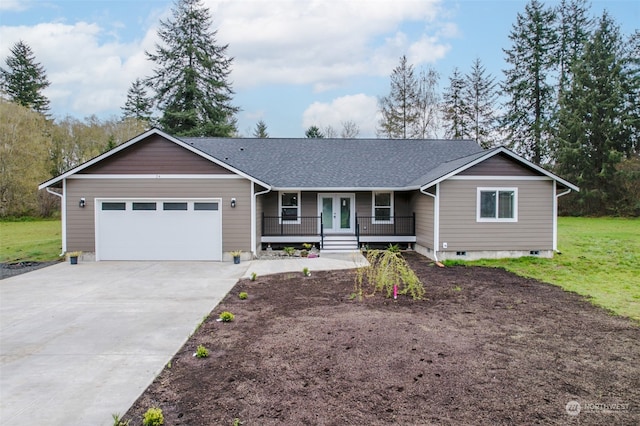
[0,219,62,262]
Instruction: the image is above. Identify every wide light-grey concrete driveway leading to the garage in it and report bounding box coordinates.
[0,262,251,425]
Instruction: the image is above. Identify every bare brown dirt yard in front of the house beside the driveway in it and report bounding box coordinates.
[124,253,640,425]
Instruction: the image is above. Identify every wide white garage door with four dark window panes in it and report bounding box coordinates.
[96,199,222,260]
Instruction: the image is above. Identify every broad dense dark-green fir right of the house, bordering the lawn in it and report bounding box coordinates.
[556,12,632,214]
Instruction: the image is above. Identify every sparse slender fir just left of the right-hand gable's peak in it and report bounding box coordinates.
[463,58,498,148]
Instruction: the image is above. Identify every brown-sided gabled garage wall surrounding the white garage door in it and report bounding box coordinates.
[65,135,253,252]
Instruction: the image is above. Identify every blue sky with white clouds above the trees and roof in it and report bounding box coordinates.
[0,0,640,137]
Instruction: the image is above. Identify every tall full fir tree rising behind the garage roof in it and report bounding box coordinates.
[147,0,238,136]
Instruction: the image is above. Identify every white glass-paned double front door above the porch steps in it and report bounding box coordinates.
[318,194,356,234]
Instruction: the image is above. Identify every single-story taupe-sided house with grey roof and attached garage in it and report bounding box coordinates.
[40,129,578,261]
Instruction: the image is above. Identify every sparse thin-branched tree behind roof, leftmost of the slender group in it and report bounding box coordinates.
[377,56,419,139]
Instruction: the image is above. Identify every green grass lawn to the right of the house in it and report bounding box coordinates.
[449,217,640,320]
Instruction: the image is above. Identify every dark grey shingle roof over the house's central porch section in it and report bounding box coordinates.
[180,138,486,189]
